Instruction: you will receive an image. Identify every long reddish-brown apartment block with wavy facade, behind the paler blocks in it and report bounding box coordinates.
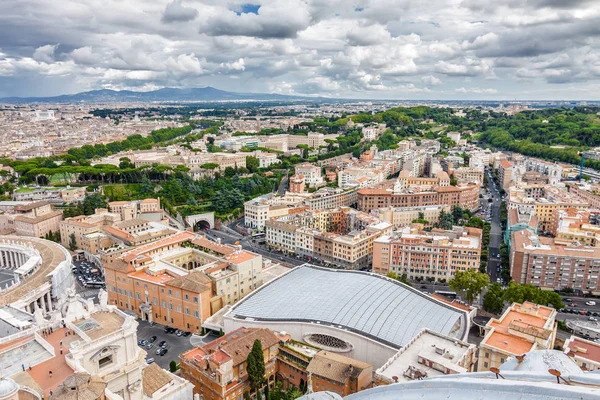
[358,183,480,212]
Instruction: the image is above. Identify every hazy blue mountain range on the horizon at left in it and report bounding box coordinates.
[0,86,331,103]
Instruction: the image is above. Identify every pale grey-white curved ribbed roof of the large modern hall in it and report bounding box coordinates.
[229,264,467,348]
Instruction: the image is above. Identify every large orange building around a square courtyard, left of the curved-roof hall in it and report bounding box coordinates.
[100,232,262,332]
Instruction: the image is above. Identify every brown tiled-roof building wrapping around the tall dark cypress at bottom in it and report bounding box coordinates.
[179,328,281,400]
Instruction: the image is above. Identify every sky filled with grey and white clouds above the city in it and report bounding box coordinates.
[0,0,600,99]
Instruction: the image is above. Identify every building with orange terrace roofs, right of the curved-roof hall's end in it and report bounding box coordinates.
[477,302,557,371]
